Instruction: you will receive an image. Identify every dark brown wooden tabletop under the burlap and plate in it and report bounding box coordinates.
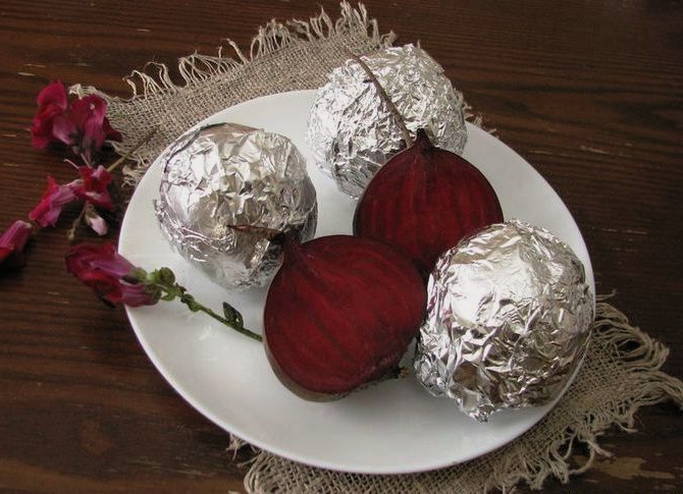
[0,0,683,493]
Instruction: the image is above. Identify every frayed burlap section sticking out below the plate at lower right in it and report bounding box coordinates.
[230,302,683,494]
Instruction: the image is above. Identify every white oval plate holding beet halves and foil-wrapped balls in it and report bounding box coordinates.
[119,91,595,473]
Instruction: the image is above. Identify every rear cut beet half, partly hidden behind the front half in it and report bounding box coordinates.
[353,131,503,276]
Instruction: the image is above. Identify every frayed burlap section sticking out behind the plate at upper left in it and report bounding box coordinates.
[70,1,396,185]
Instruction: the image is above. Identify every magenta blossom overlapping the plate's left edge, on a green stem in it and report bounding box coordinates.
[66,242,160,307]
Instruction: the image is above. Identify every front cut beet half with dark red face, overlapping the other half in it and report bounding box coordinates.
[264,235,427,400]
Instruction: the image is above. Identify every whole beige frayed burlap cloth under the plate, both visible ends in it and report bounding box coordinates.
[72,2,683,494]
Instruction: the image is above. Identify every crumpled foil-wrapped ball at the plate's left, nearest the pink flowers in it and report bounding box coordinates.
[155,123,318,288]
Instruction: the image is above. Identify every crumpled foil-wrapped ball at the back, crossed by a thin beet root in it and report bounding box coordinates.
[306,45,467,197]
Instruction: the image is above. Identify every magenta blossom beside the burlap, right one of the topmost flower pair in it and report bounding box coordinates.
[52,94,121,163]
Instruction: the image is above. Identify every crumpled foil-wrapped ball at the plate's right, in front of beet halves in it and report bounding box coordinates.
[415,220,594,422]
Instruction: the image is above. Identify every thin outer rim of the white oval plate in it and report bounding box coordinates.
[117,89,595,475]
